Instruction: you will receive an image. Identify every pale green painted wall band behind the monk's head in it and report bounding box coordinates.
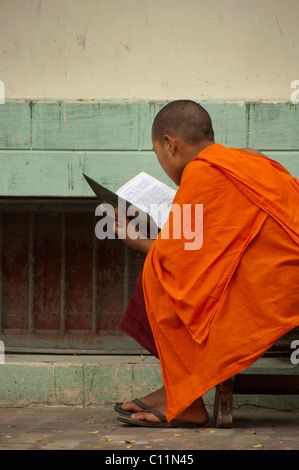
[0,101,299,196]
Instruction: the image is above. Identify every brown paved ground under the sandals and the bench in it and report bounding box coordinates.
[0,405,299,452]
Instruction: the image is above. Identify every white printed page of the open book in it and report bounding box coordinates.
[116,172,176,228]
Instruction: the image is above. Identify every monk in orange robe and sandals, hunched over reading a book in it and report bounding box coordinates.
[115,100,299,427]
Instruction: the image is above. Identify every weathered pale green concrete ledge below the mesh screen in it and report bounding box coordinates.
[0,354,299,410]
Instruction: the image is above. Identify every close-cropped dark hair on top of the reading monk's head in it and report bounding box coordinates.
[152,100,214,145]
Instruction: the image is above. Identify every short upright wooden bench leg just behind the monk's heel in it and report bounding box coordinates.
[214,377,234,428]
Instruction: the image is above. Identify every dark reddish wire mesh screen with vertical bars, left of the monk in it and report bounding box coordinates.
[0,200,145,354]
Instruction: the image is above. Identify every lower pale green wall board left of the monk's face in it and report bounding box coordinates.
[0,150,174,197]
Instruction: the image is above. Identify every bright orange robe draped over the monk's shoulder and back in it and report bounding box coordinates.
[143,144,299,420]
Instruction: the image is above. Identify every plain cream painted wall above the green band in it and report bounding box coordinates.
[0,0,299,100]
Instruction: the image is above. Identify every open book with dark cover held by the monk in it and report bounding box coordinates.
[84,172,176,229]
